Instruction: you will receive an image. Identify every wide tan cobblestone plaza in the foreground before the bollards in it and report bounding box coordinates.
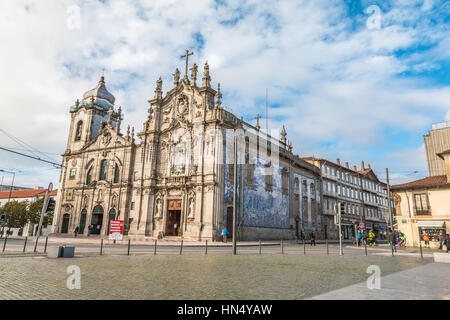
[0,253,432,300]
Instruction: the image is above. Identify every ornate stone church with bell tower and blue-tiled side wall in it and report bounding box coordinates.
[53,52,326,241]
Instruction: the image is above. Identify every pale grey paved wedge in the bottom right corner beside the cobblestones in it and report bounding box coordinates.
[311,263,450,300]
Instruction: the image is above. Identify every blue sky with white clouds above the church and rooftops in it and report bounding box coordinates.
[0,0,450,186]
